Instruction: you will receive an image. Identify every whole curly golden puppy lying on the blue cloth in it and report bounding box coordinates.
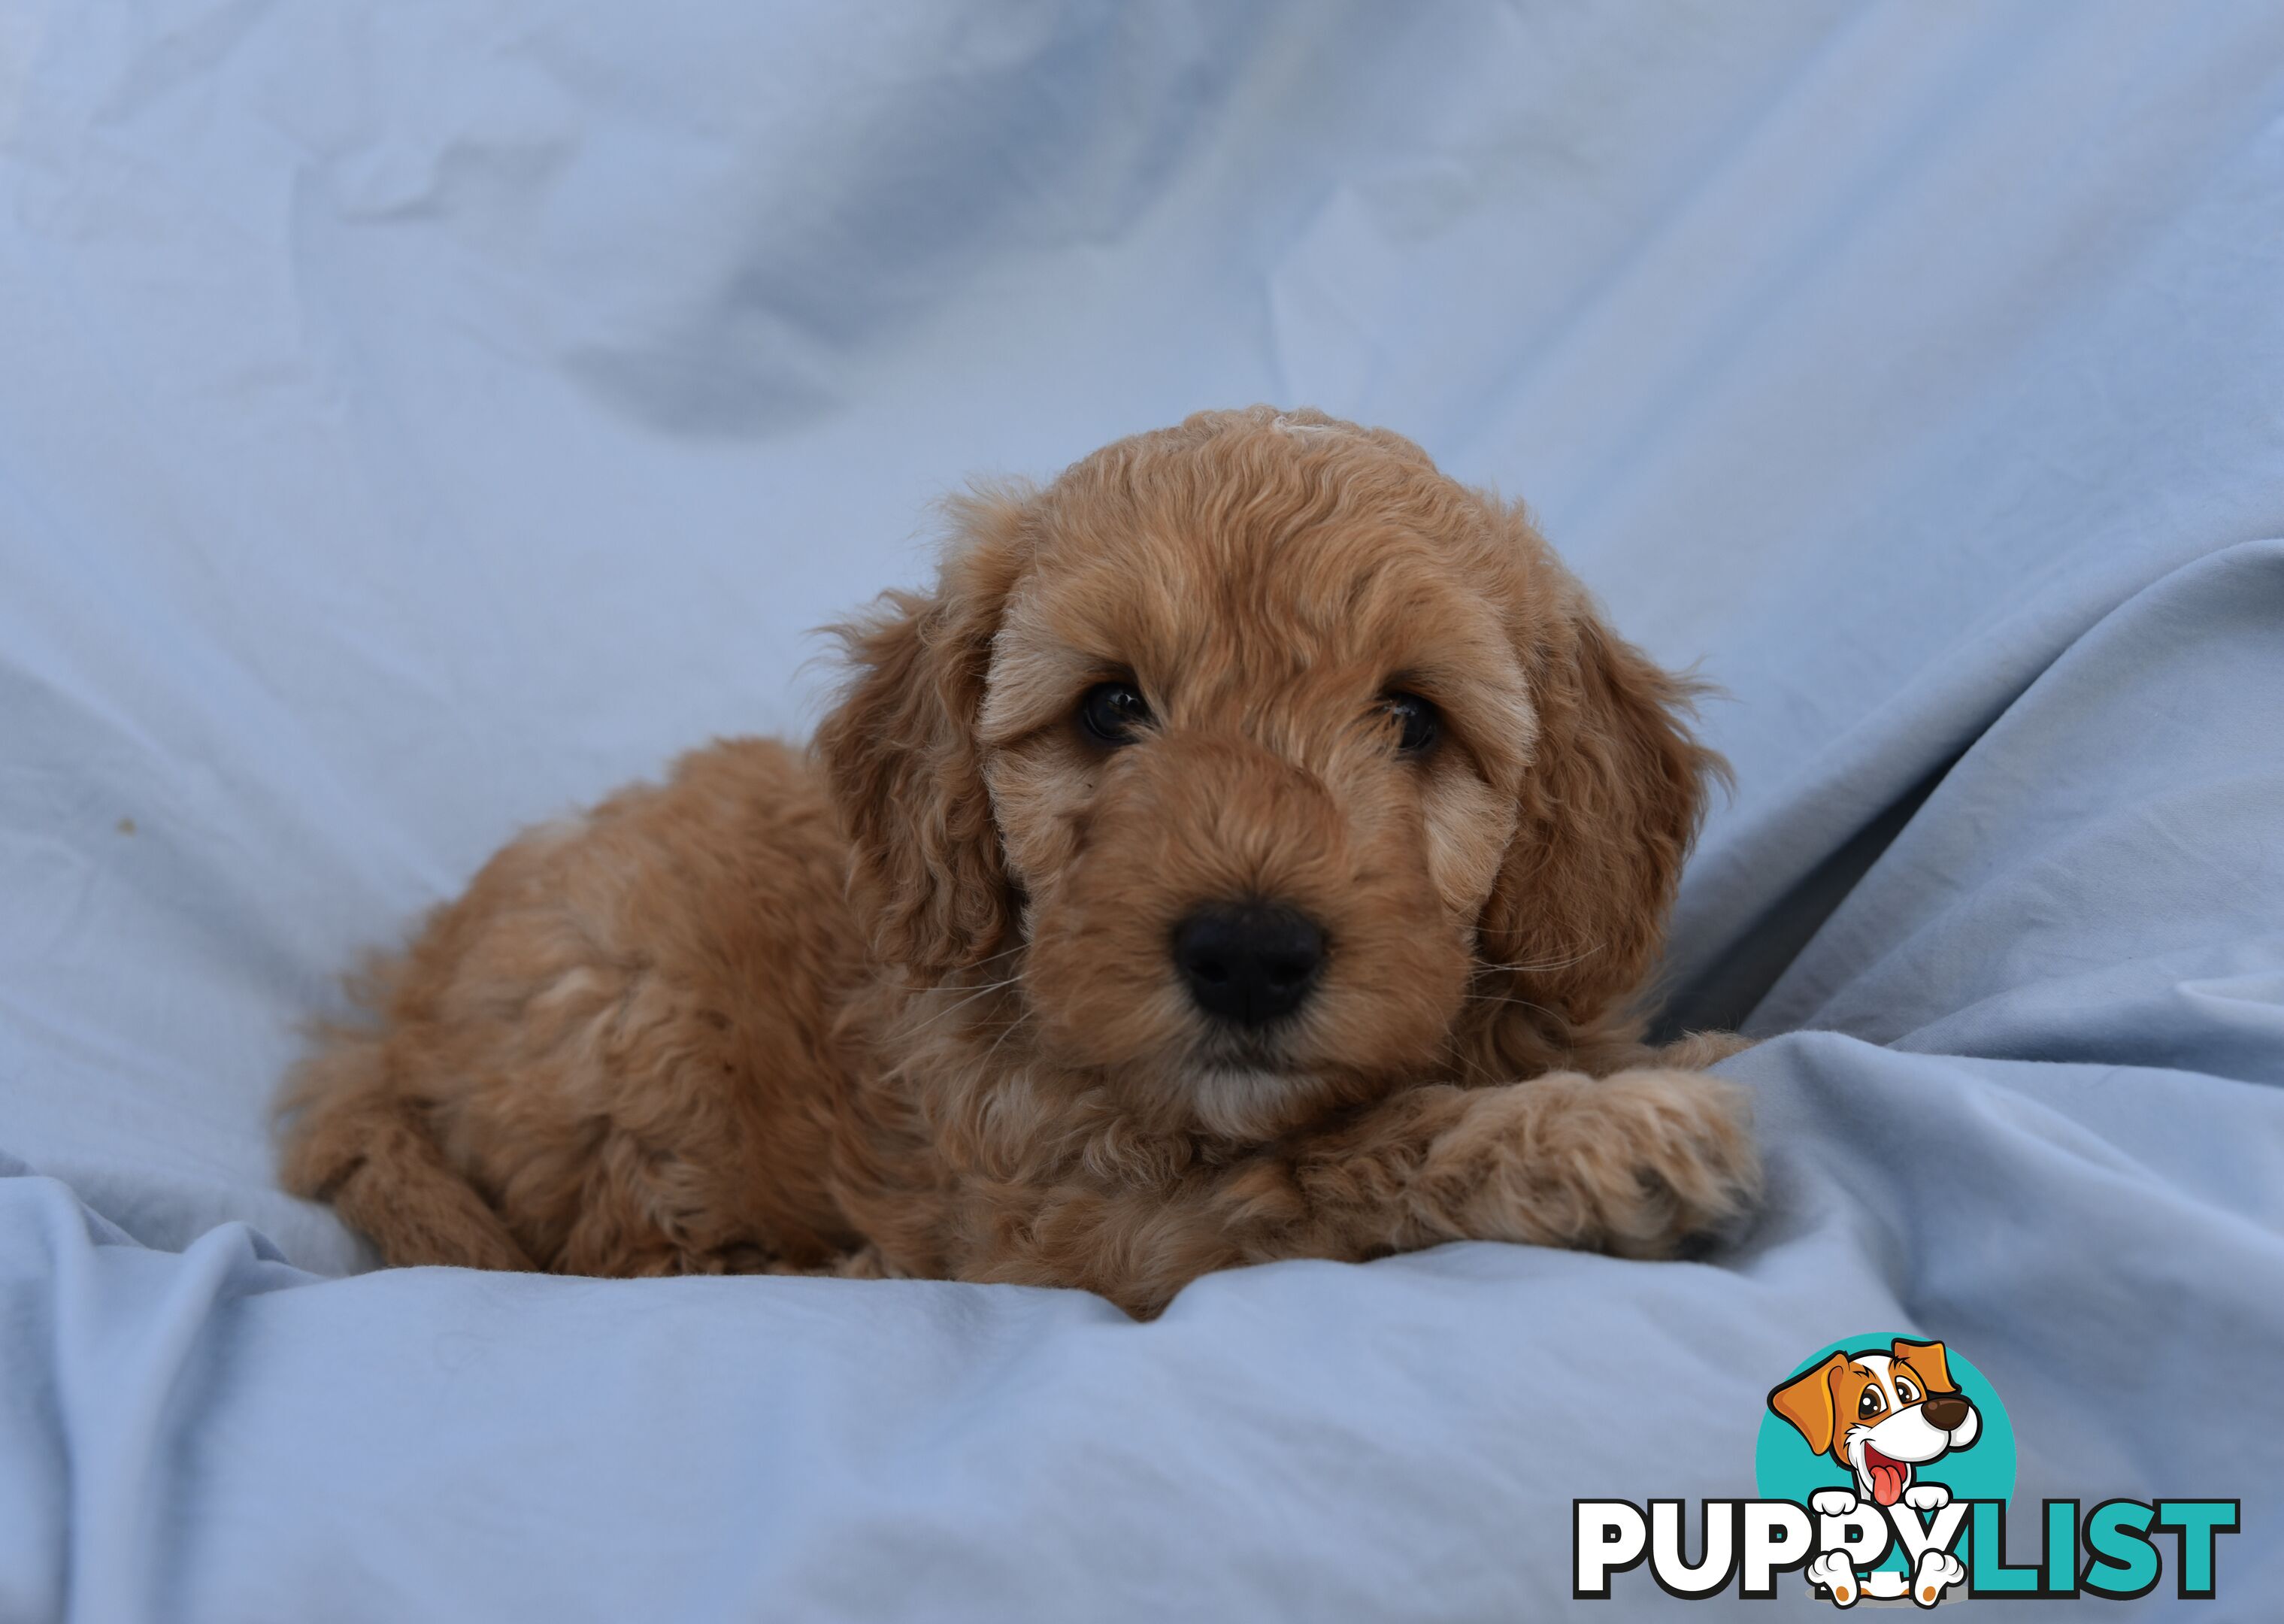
[286,409,1756,1313]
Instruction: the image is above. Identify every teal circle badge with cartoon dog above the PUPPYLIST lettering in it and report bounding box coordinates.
[1752,1332,2015,1567]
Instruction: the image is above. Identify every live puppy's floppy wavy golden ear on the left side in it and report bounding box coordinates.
[818,491,1032,975]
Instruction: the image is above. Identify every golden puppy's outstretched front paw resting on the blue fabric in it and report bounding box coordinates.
[1425,1071,1761,1259]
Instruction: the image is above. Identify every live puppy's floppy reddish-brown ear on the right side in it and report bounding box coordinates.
[1478,509,1729,1037]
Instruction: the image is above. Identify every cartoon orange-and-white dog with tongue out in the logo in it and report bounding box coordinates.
[1768,1338,1983,1606]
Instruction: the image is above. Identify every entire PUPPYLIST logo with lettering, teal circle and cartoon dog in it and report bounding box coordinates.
[1571,1336,2238,1608]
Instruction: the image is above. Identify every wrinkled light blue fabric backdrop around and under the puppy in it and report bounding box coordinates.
[0,0,2284,1619]
